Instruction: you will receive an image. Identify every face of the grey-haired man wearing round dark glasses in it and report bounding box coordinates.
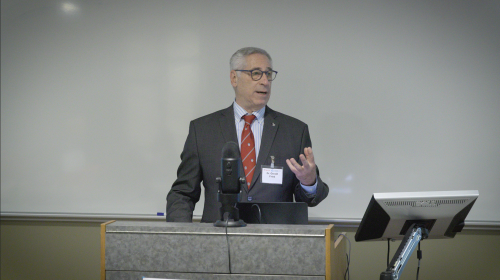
[230,54,272,113]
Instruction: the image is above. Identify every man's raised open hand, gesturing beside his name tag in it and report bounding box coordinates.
[286,147,316,186]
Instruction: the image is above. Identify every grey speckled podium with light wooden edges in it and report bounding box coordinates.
[101,221,347,280]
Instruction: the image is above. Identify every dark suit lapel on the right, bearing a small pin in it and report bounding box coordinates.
[251,107,279,187]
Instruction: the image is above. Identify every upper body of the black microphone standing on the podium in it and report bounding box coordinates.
[221,142,241,194]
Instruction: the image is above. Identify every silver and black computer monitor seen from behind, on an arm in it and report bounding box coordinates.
[355,190,479,241]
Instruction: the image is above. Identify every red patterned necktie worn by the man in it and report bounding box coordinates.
[241,115,255,188]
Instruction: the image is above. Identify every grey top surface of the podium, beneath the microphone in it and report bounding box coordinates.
[106,221,328,237]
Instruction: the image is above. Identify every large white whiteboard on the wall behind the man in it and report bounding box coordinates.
[1,0,500,221]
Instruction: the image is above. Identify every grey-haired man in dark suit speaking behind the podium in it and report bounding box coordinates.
[167,48,328,222]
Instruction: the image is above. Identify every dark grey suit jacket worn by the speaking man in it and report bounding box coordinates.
[167,105,328,222]
